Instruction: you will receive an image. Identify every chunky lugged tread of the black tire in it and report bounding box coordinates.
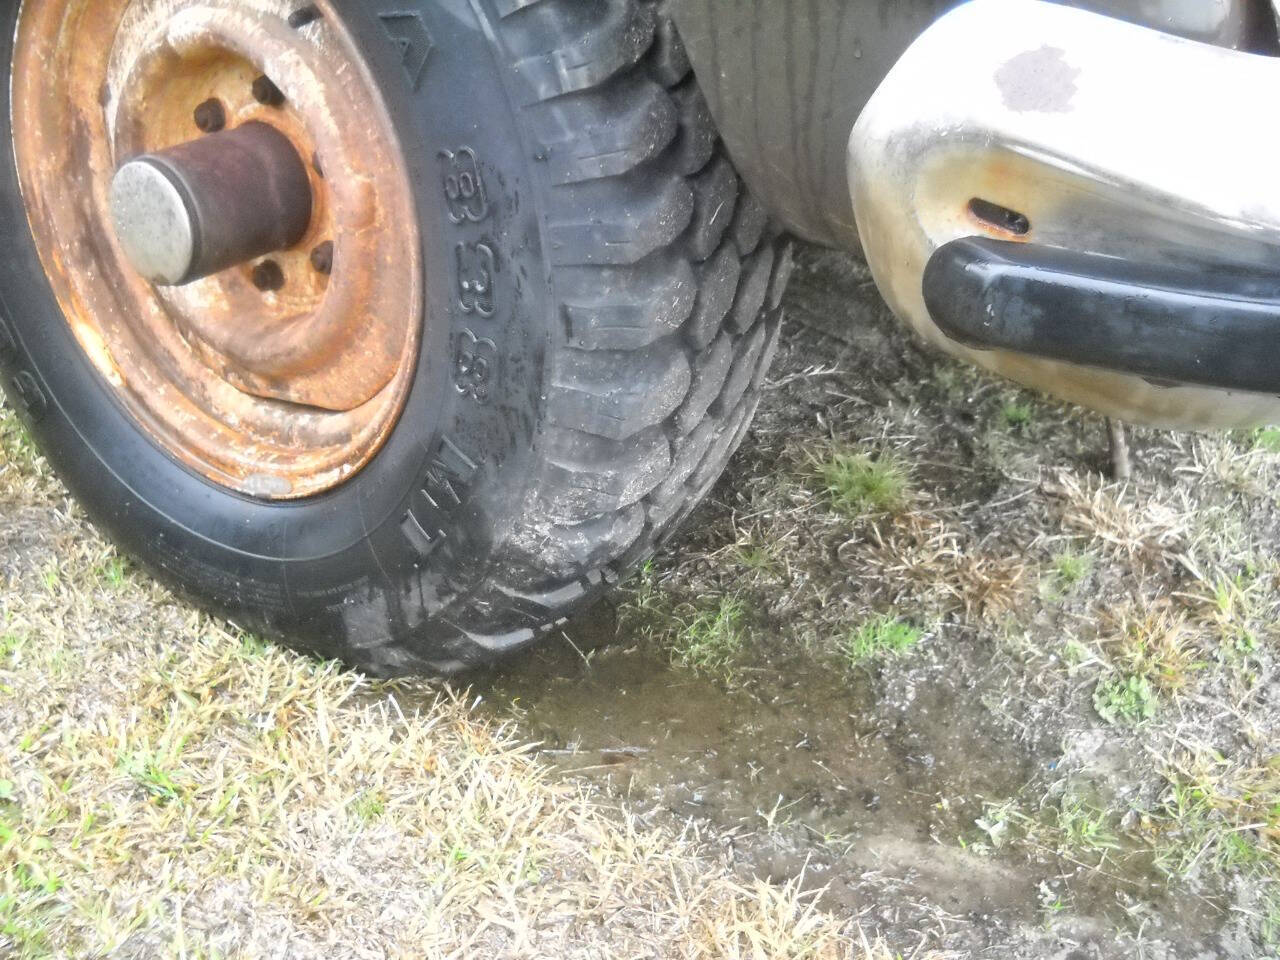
[409,0,786,664]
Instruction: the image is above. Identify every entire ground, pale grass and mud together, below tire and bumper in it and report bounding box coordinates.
[0,250,1280,960]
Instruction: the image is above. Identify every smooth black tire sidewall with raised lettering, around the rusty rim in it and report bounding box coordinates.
[0,0,550,663]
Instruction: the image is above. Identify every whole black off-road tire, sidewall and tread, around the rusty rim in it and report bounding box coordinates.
[0,0,790,676]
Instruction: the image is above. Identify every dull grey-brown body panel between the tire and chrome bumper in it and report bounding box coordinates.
[673,0,1275,250]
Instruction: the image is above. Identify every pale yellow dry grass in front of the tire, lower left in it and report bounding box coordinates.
[0,419,884,960]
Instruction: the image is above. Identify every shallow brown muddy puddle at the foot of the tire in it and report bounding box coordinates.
[458,608,1208,956]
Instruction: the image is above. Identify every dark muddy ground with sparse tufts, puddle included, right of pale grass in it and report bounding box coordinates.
[465,250,1280,960]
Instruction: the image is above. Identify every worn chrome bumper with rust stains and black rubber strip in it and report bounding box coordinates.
[849,0,1280,429]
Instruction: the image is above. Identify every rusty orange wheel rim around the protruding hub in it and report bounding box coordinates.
[12,0,422,499]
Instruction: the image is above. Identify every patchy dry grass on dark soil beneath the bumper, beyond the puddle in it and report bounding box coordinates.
[614,253,1280,955]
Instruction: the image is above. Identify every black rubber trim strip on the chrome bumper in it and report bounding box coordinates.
[924,237,1280,393]
